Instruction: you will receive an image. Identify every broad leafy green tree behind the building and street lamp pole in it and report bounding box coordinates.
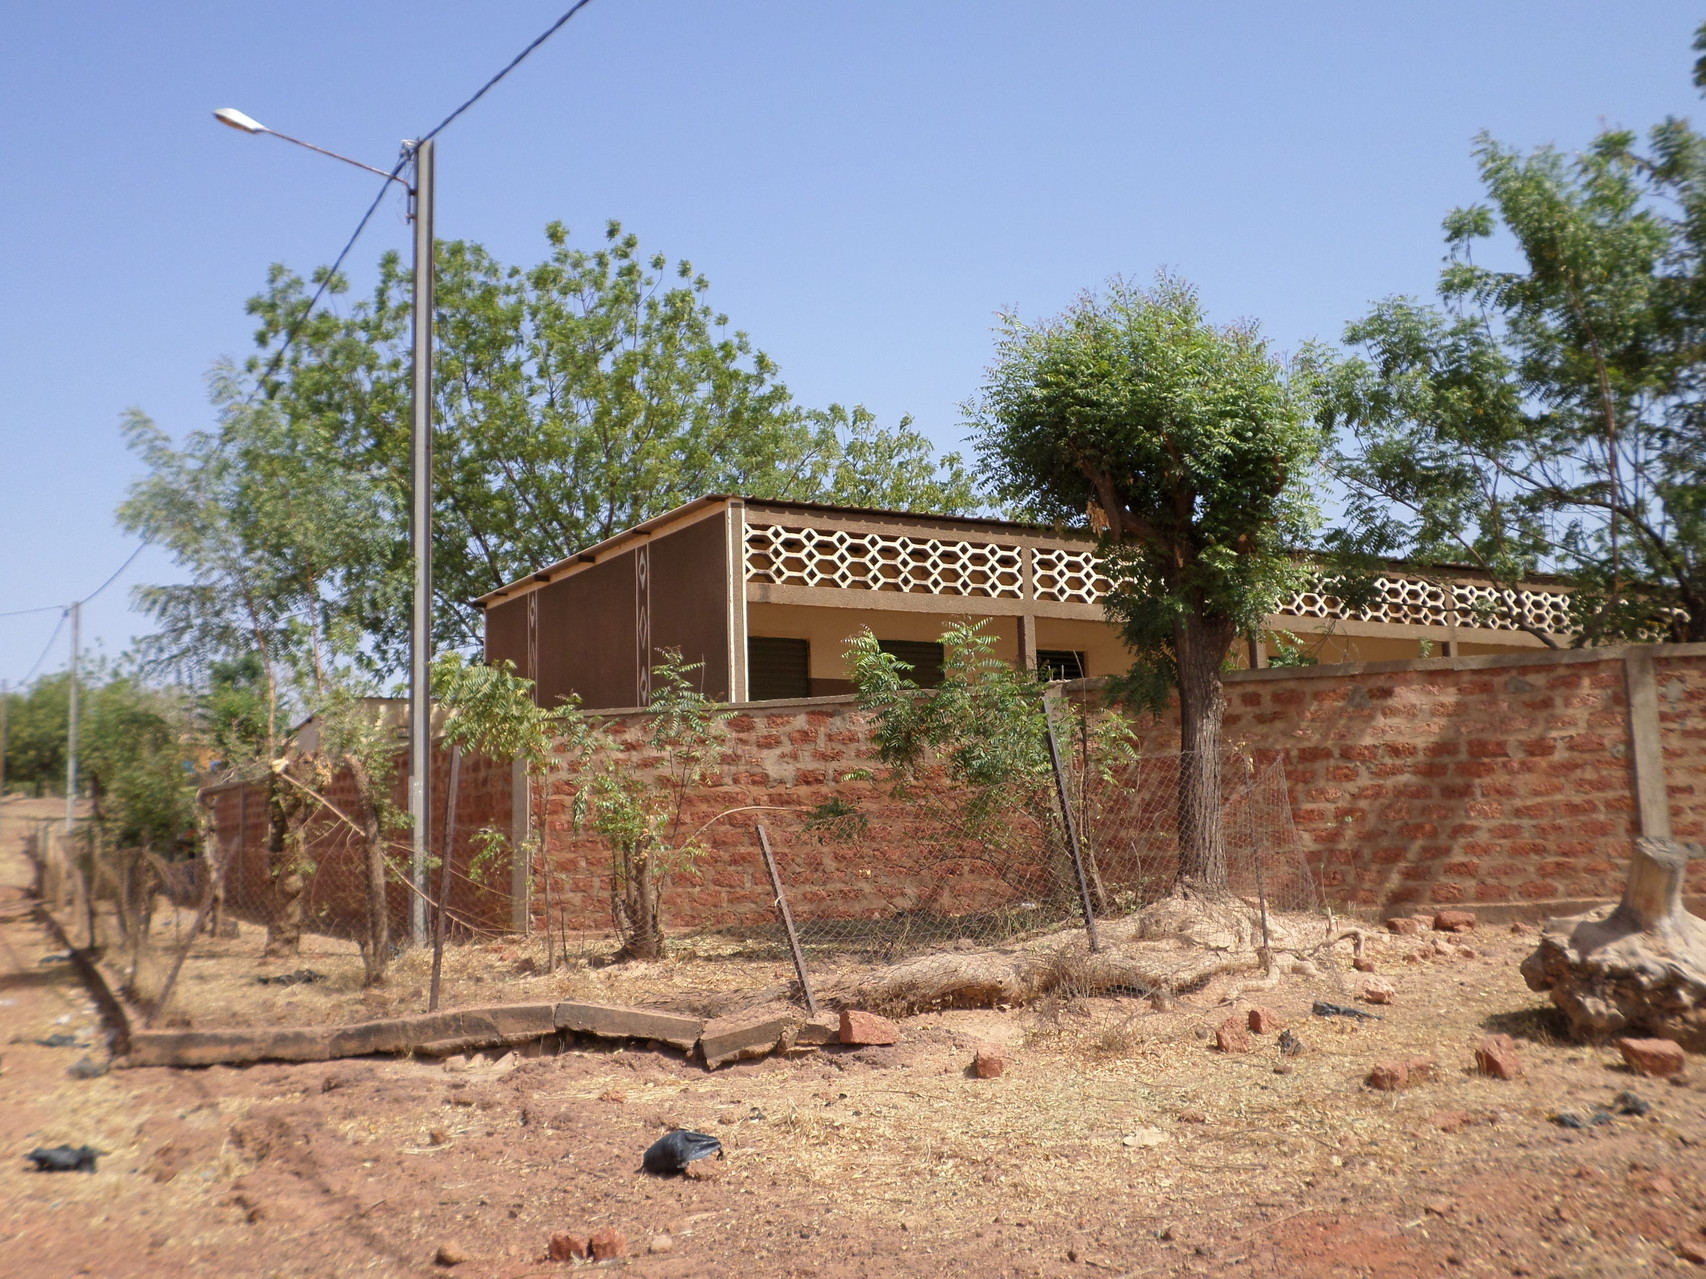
[230,223,976,668]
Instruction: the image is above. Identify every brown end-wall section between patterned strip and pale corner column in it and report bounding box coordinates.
[650,518,732,699]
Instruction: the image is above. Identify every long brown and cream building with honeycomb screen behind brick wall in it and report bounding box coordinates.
[478,495,1568,709]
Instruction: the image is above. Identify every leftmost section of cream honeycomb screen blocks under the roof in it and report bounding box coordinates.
[746,524,1025,600]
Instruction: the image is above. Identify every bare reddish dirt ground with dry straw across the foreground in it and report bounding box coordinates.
[0,805,1706,1279]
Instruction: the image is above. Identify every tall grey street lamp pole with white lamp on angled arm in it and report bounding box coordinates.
[213,107,433,946]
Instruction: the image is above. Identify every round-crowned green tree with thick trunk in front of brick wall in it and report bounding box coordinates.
[969,275,1320,894]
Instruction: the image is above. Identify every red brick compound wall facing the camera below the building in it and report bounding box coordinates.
[534,645,1706,928]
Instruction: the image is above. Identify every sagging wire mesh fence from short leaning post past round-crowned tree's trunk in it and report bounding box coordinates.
[672,750,1338,1008]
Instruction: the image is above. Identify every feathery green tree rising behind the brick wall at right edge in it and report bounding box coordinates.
[1324,40,1706,645]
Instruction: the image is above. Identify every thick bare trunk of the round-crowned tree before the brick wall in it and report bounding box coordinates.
[1174,616,1237,895]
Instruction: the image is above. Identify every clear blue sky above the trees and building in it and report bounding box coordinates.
[0,0,1703,684]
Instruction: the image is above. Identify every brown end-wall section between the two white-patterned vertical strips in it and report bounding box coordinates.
[539,551,640,708]
